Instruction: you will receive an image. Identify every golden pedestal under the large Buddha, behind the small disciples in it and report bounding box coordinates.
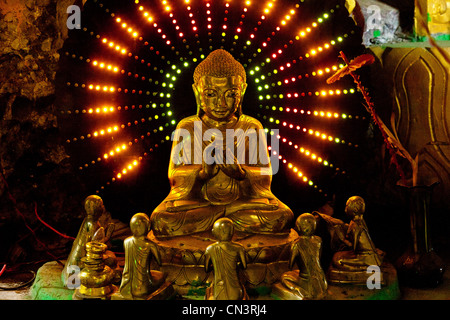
[149,229,298,298]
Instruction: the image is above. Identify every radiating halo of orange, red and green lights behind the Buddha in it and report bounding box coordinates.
[61,0,365,196]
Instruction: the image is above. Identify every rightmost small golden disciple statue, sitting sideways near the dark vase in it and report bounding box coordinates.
[332,196,384,271]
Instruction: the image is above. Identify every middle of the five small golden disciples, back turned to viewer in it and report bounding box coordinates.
[205,218,248,300]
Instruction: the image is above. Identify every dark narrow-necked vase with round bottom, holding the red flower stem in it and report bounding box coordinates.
[396,183,445,288]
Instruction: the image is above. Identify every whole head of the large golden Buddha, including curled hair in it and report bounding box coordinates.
[192,49,247,121]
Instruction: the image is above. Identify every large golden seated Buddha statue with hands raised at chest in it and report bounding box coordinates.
[151,49,293,237]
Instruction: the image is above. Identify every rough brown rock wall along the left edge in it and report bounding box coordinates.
[0,0,85,262]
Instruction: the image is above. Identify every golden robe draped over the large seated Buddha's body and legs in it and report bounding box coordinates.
[151,115,293,236]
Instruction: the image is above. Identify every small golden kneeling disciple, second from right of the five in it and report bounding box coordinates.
[281,213,328,300]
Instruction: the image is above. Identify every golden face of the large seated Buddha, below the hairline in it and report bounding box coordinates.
[193,76,247,121]
